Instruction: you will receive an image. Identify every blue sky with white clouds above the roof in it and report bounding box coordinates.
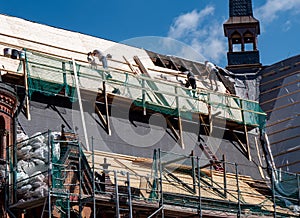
[0,0,300,67]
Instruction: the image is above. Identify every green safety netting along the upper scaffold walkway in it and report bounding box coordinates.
[26,53,266,129]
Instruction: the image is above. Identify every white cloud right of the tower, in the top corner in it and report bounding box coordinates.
[254,0,300,23]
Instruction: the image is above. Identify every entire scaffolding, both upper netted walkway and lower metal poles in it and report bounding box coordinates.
[1,51,300,218]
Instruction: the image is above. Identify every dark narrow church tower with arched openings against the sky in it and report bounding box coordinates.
[223,0,261,72]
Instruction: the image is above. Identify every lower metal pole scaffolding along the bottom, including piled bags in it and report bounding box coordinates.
[2,131,300,218]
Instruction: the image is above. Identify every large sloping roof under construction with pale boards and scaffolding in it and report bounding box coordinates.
[0,15,299,217]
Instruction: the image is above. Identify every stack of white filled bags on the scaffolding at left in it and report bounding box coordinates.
[17,132,60,202]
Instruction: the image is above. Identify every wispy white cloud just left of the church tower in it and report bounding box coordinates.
[168,6,227,64]
